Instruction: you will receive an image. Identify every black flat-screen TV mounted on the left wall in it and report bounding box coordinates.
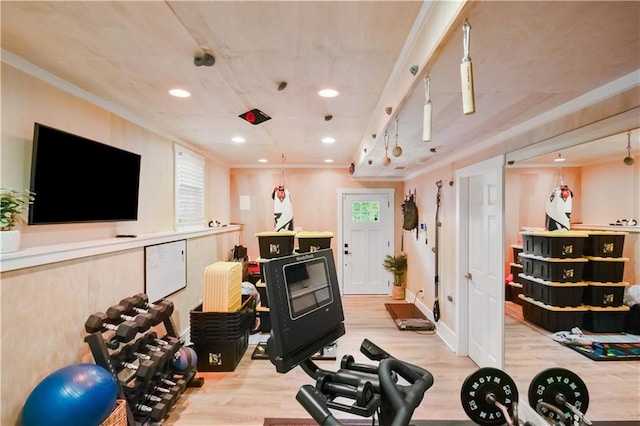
[29,123,141,225]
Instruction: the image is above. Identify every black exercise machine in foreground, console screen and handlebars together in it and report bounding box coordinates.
[263,249,433,426]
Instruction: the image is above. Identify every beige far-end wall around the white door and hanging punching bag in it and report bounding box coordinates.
[231,168,403,259]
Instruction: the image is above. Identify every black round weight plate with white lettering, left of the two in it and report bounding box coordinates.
[460,367,518,425]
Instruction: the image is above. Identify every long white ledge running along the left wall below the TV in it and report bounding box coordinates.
[0,225,242,272]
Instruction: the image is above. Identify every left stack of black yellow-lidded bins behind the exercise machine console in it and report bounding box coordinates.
[256,231,296,333]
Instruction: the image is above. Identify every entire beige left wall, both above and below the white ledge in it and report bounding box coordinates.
[0,63,239,425]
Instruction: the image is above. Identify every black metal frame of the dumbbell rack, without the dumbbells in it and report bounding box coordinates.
[84,294,203,426]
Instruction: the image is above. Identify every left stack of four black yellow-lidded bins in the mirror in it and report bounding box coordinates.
[518,231,588,332]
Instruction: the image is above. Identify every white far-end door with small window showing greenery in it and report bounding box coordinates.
[338,190,393,294]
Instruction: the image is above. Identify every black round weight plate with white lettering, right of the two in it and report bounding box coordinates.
[529,368,589,421]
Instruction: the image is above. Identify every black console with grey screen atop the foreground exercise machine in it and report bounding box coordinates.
[263,249,345,373]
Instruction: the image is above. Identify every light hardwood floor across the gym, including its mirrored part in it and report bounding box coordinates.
[165,296,640,426]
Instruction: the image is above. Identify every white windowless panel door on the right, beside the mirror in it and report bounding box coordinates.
[457,156,504,368]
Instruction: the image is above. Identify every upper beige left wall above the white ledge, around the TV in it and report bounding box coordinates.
[0,63,230,248]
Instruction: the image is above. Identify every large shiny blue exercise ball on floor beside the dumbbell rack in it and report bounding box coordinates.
[22,364,118,426]
